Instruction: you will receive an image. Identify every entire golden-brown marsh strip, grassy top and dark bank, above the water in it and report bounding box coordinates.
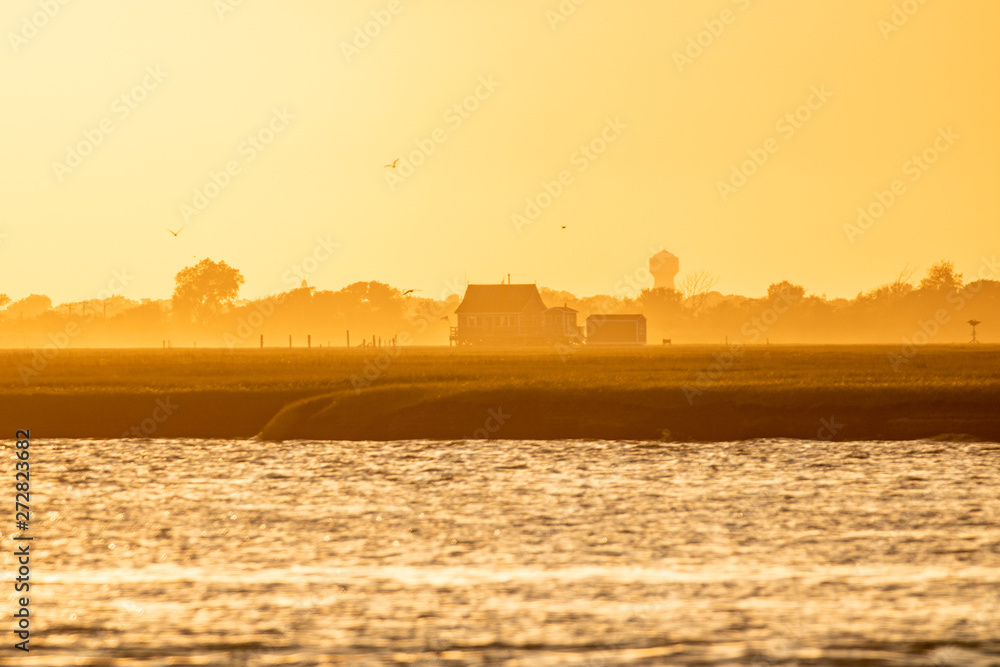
[0,345,1000,441]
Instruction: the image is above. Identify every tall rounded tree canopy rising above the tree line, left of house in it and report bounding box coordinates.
[171,259,246,322]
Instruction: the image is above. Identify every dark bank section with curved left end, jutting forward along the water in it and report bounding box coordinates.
[260,386,1000,442]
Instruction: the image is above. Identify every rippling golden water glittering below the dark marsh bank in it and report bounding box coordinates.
[7,440,1000,666]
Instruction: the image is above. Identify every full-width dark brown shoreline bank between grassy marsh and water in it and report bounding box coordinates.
[0,385,1000,442]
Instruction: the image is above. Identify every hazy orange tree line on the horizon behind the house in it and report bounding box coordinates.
[0,259,1000,347]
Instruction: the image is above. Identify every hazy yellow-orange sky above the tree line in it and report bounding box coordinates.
[0,0,1000,302]
